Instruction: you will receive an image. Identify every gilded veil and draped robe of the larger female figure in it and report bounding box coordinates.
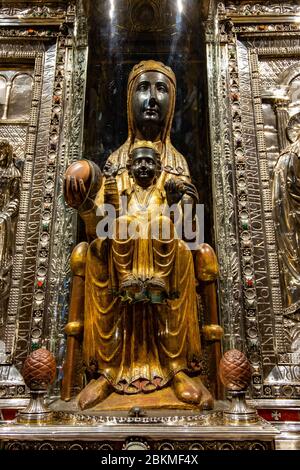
[79,61,201,393]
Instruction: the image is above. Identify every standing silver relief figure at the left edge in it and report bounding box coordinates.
[0,140,21,327]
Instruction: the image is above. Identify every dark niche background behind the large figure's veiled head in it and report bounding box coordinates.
[84,0,213,244]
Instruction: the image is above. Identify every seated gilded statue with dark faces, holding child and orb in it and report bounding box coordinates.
[62,60,221,409]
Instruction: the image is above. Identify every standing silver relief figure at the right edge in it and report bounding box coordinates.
[272,114,300,352]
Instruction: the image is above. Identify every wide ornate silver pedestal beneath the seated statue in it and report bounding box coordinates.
[0,404,279,451]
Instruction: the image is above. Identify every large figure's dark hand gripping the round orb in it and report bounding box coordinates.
[64,160,91,209]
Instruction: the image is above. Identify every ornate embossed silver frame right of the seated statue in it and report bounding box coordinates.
[207,2,300,399]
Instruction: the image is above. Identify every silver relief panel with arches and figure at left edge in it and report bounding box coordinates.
[0,65,33,337]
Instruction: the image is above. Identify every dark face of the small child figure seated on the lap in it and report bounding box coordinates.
[131,147,156,188]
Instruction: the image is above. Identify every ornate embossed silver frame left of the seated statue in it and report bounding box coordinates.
[0,0,88,399]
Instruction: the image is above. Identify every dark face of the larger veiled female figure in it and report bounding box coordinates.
[132,72,171,134]
